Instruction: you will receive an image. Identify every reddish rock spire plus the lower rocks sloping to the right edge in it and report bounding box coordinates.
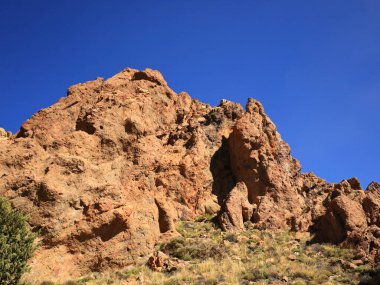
[219,99,380,264]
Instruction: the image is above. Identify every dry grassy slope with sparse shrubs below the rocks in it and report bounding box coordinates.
[35,217,376,285]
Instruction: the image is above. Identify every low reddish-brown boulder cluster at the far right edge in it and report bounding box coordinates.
[313,181,380,264]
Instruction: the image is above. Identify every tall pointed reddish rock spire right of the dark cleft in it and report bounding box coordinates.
[229,99,307,230]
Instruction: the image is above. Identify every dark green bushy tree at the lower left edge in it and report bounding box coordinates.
[0,197,35,285]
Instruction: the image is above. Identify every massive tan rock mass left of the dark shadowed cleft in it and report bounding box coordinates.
[0,69,243,280]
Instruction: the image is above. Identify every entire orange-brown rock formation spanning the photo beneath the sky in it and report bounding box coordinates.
[0,69,380,280]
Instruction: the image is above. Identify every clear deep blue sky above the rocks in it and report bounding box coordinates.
[0,0,380,186]
